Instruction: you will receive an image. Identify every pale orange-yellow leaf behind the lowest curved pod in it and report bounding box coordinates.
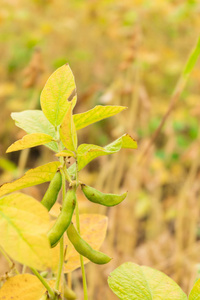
[52,214,108,273]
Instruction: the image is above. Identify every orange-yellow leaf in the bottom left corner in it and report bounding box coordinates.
[0,274,45,300]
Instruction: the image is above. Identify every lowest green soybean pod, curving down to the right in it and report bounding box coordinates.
[67,223,111,265]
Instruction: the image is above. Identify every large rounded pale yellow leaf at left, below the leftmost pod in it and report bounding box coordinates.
[0,193,51,270]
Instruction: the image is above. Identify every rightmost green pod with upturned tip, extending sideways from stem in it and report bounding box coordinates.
[81,184,127,206]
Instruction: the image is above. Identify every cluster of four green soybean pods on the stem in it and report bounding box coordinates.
[45,172,127,264]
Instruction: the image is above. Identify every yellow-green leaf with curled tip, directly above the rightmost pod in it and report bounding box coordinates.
[77,134,137,171]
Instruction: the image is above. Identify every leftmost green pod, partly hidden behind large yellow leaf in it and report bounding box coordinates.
[41,172,62,211]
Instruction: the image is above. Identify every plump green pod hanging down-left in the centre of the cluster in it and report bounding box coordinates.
[47,188,76,247]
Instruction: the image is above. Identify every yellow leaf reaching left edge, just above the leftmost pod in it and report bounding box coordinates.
[0,161,60,197]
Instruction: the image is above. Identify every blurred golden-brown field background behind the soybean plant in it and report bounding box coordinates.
[0,0,200,300]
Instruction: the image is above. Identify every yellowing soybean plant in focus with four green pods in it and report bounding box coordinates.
[0,64,137,300]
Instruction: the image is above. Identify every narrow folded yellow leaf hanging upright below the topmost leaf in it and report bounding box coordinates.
[60,100,77,152]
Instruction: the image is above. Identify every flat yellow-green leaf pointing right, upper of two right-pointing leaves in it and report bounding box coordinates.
[73,105,127,130]
